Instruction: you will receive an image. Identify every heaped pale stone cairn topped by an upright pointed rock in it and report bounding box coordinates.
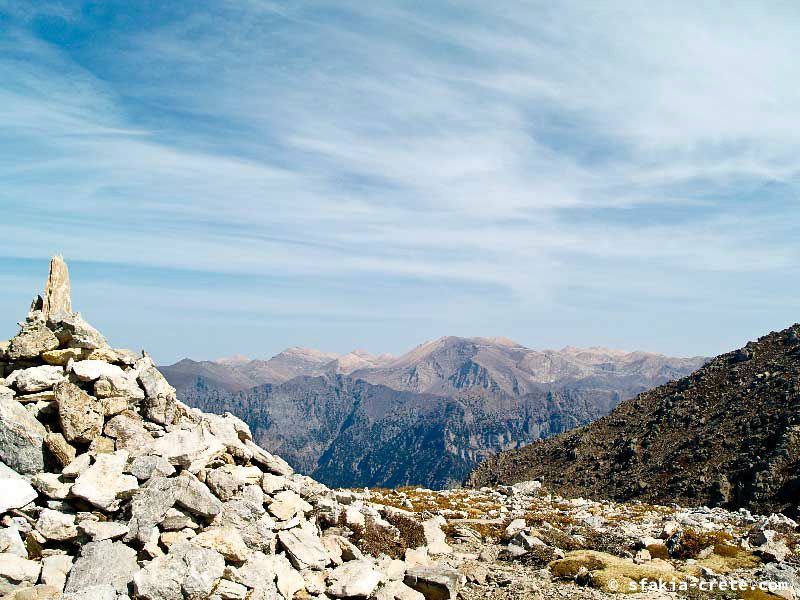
[0,257,463,600]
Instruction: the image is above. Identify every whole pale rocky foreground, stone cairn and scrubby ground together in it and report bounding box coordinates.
[0,260,800,600]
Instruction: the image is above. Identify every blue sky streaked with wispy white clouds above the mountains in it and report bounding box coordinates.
[0,0,800,364]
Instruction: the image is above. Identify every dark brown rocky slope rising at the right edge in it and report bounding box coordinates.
[469,325,800,513]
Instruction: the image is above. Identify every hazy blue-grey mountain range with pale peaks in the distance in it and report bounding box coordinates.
[160,337,705,487]
